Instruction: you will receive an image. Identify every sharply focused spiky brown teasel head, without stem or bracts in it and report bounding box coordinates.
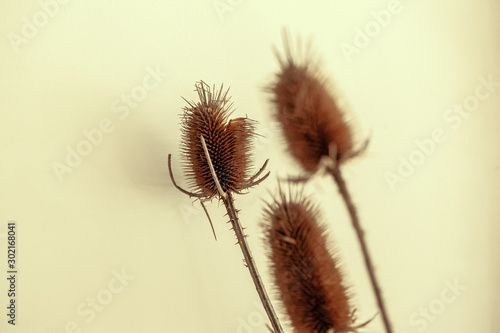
[181,81,255,198]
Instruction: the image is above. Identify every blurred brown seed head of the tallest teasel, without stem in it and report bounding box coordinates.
[269,33,352,171]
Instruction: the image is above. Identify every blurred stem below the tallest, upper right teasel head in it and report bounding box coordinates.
[330,165,392,333]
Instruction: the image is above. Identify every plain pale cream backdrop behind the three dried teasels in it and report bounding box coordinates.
[0,0,500,333]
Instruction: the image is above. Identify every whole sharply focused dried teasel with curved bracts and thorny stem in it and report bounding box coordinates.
[168,81,283,333]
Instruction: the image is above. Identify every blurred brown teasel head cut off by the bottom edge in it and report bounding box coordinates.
[264,190,354,333]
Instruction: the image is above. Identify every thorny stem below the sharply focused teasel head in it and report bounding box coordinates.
[222,192,283,333]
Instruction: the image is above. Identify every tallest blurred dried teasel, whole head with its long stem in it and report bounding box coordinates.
[269,31,392,333]
